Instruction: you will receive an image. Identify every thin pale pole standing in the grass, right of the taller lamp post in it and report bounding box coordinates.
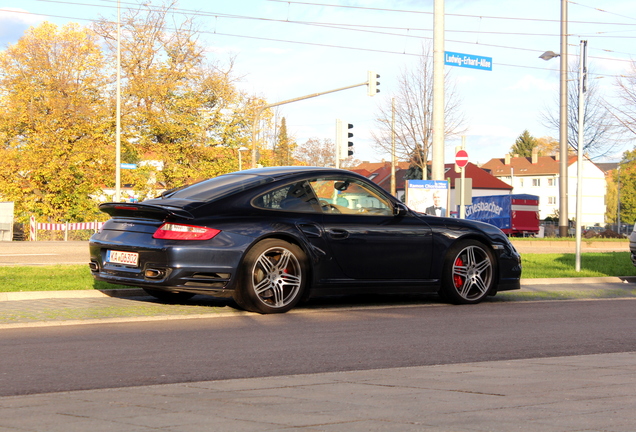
[574,41,587,271]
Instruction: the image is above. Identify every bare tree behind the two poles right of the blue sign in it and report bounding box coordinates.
[541,62,618,158]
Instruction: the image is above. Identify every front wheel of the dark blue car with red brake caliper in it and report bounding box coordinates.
[439,240,496,304]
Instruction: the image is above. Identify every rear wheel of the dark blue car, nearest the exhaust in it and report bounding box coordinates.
[234,239,308,314]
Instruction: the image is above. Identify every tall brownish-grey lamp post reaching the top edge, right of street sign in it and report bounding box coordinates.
[559,0,569,237]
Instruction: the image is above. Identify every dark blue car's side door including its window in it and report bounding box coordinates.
[310,175,433,280]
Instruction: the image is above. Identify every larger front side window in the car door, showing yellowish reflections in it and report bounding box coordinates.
[310,178,393,216]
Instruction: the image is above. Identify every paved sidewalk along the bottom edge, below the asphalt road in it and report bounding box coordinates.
[0,352,636,432]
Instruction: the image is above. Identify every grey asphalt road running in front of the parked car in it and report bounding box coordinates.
[0,299,636,396]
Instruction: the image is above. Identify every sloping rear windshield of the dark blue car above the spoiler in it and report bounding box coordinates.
[164,174,270,202]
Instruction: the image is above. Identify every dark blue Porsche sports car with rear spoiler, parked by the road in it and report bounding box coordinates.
[90,167,521,313]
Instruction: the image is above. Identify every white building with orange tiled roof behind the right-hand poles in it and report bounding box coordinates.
[481,149,607,226]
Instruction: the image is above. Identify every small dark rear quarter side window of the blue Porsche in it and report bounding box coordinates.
[253,181,320,213]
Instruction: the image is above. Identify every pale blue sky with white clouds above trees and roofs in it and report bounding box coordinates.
[0,0,636,163]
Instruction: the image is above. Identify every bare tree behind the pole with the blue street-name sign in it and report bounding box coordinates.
[372,46,464,178]
